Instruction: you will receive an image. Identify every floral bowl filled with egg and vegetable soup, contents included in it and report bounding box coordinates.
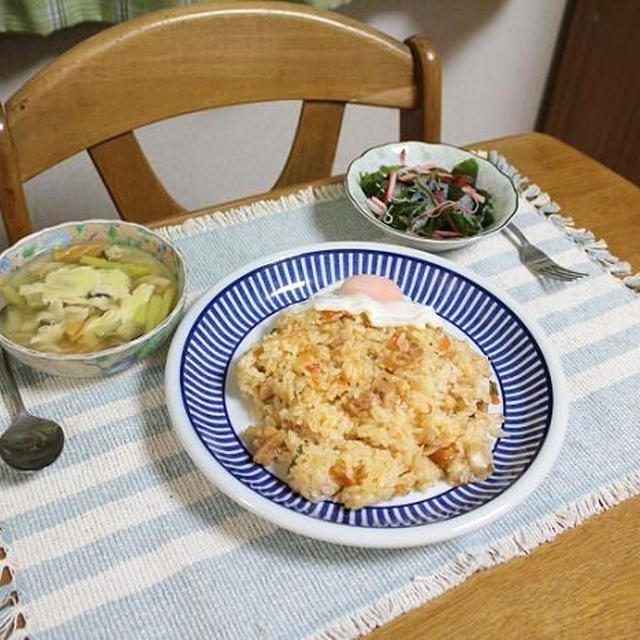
[0,220,186,376]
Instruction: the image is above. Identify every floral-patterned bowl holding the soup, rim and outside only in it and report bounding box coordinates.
[0,220,187,377]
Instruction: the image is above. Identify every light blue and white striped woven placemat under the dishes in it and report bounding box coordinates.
[0,154,640,640]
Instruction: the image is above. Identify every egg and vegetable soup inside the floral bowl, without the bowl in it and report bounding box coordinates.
[0,243,177,354]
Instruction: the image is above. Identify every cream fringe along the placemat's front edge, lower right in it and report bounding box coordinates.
[305,471,640,640]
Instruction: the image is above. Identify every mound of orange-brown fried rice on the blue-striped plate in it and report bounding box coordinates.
[236,309,502,508]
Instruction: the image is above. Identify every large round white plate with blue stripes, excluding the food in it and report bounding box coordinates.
[165,242,568,547]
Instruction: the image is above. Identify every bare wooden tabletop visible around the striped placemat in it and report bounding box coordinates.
[152,133,640,640]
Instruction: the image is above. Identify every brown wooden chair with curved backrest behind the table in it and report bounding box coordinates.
[0,1,441,242]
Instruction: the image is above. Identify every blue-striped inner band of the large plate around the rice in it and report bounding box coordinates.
[180,249,553,528]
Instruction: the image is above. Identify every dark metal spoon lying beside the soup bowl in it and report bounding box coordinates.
[0,349,64,471]
